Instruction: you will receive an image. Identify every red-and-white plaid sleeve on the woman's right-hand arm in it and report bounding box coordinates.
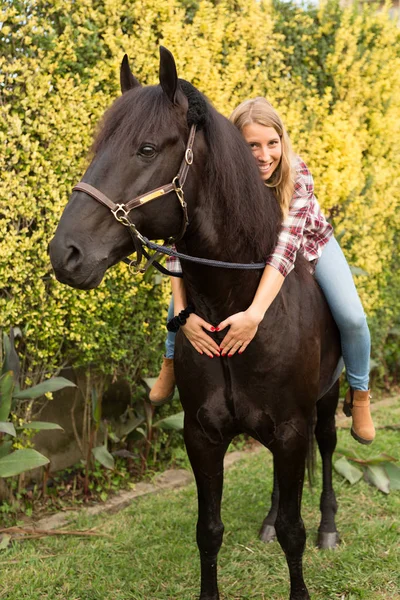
[267,163,314,277]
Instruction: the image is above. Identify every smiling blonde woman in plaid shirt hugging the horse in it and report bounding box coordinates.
[150,98,375,444]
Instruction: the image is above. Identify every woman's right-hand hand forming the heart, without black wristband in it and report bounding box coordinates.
[216,308,263,356]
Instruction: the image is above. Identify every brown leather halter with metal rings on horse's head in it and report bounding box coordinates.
[72,125,196,256]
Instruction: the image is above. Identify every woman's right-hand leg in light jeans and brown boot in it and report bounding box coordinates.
[315,237,375,443]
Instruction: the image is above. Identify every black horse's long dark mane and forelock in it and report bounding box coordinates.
[92,79,282,262]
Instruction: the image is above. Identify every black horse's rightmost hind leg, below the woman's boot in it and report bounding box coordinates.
[315,382,340,549]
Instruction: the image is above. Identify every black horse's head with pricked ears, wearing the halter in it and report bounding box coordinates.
[50,47,202,289]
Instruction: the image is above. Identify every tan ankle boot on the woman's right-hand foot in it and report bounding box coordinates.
[343,388,375,444]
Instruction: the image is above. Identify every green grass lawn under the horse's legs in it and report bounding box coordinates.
[0,401,400,600]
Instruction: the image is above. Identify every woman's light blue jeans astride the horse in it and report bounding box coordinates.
[165,236,371,391]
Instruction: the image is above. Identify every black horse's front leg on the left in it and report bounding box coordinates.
[184,422,232,600]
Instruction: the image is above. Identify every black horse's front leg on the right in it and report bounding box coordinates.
[271,423,310,600]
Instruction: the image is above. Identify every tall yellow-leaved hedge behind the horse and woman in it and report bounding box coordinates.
[0,0,400,384]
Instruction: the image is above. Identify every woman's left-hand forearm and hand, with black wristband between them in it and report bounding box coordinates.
[171,277,219,358]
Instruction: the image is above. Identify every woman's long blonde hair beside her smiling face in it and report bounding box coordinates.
[229,97,295,218]
